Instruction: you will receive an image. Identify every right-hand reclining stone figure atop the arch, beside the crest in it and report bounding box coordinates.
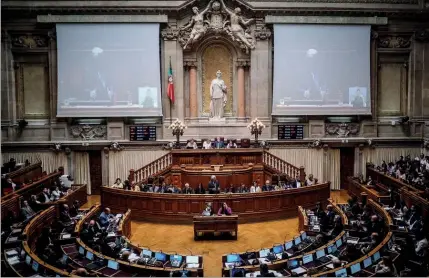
[220,0,255,49]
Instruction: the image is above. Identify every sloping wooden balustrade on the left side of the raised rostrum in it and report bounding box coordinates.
[128,153,172,183]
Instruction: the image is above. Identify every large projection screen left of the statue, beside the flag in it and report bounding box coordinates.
[56,23,162,117]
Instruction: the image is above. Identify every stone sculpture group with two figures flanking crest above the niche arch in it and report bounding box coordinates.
[179,0,255,53]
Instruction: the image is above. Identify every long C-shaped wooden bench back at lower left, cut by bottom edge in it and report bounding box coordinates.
[22,206,70,277]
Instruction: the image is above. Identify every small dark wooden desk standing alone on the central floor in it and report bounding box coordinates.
[194,215,238,240]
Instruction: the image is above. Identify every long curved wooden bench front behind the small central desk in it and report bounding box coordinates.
[101,182,330,223]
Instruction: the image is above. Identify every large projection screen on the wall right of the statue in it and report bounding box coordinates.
[272,24,371,116]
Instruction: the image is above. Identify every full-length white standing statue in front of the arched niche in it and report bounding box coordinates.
[210,70,227,119]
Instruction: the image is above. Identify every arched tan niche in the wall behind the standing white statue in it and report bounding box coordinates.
[194,35,250,117]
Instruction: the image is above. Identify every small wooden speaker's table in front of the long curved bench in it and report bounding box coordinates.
[194,215,238,240]
